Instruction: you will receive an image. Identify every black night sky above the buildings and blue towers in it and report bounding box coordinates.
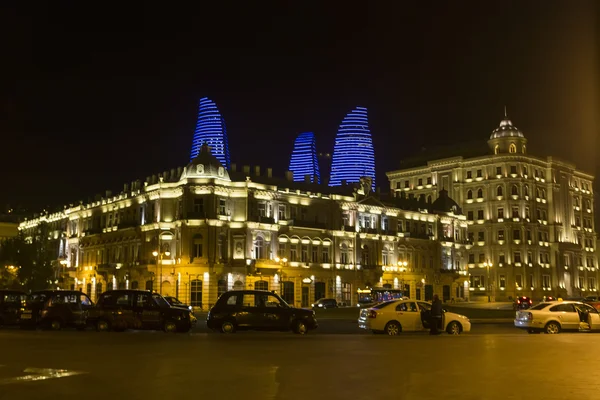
[0,0,600,225]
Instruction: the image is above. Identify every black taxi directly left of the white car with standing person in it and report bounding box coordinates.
[206,290,318,335]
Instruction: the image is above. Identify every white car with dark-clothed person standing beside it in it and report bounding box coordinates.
[358,300,471,336]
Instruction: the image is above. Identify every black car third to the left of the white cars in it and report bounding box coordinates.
[19,290,94,330]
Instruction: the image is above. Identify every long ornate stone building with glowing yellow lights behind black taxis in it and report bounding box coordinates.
[19,146,470,309]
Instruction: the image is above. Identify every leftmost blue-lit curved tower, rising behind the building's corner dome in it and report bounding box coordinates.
[191,97,231,169]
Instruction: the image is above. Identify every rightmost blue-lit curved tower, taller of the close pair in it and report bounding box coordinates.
[329,107,375,188]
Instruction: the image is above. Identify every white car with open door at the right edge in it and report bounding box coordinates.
[515,300,600,334]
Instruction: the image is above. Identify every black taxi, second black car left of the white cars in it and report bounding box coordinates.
[88,289,196,332]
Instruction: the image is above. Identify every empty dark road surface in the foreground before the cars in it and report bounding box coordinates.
[0,330,600,400]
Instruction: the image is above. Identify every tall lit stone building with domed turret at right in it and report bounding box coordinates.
[387,115,598,301]
